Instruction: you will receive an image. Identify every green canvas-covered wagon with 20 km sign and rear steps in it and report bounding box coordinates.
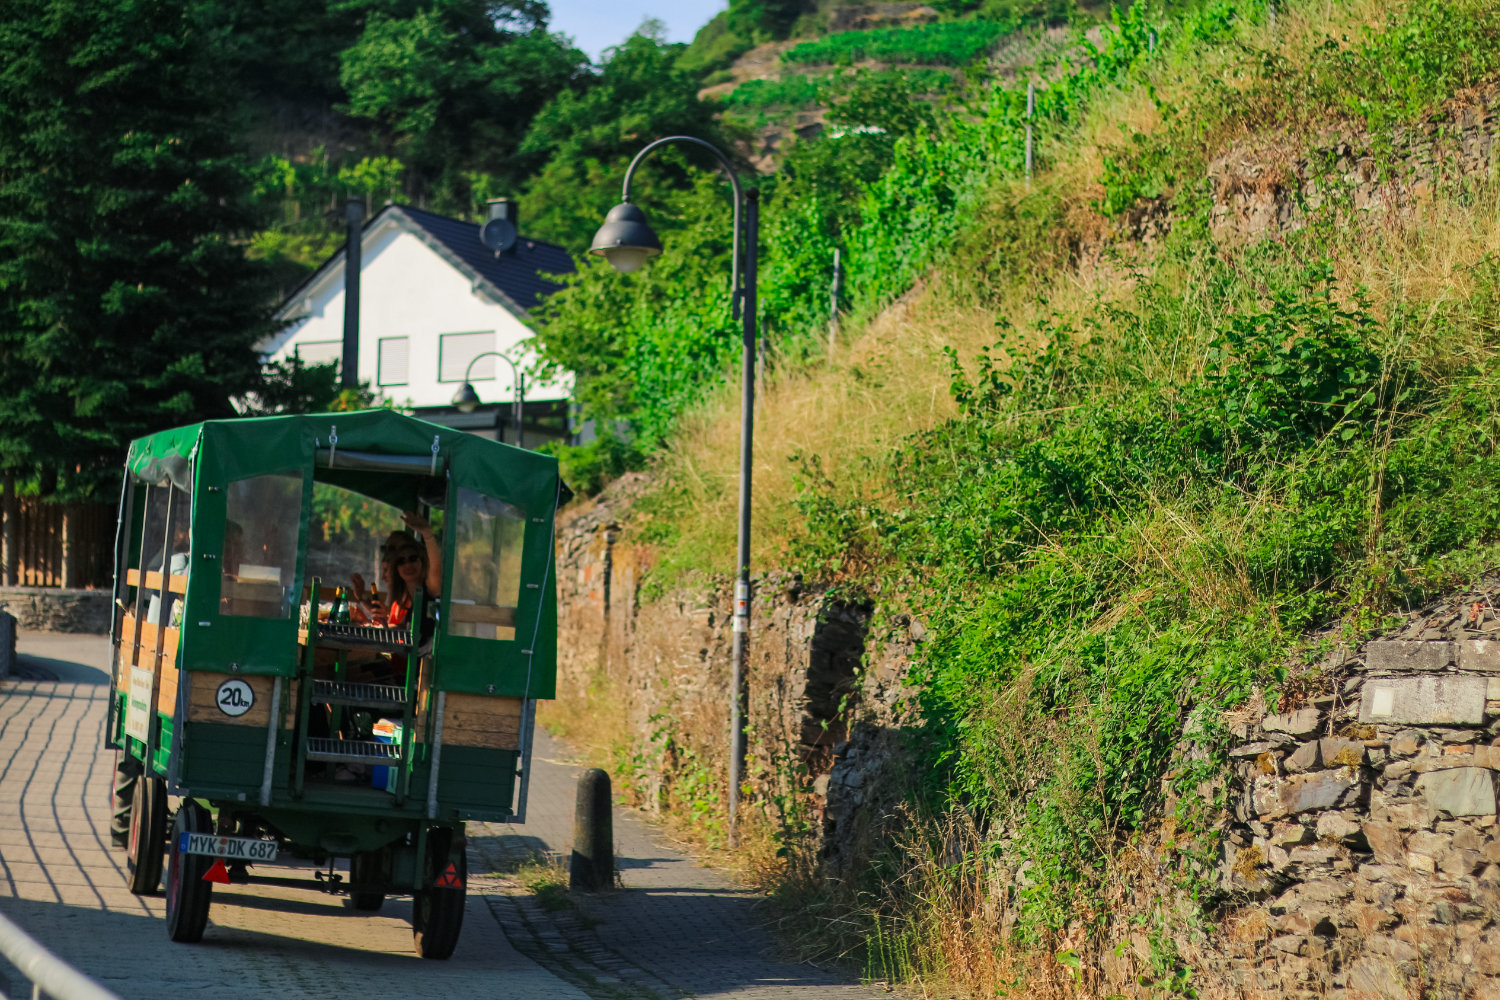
[107,409,567,958]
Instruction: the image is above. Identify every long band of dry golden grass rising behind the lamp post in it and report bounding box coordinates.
[633,0,1428,587]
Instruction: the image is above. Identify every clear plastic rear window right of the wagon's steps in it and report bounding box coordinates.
[446,487,527,640]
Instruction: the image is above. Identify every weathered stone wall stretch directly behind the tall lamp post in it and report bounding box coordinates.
[558,477,890,827]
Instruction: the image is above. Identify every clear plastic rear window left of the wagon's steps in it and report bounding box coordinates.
[219,474,302,618]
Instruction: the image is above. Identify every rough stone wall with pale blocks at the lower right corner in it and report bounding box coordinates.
[1218,594,1500,1000]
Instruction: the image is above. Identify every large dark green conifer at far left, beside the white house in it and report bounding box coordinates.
[0,0,269,495]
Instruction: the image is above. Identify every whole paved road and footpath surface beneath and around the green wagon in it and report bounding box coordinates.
[0,634,881,1000]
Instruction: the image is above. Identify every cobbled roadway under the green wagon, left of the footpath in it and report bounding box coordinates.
[0,636,585,1000]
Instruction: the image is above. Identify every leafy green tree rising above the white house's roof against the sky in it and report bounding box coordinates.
[339,0,588,204]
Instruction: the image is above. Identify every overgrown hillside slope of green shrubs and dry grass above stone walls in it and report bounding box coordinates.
[546,0,1500,996]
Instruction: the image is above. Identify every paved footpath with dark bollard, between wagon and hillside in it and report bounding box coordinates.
[470,730,888,1000]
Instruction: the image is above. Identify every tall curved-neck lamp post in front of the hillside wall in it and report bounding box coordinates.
[588,135,761,846]
